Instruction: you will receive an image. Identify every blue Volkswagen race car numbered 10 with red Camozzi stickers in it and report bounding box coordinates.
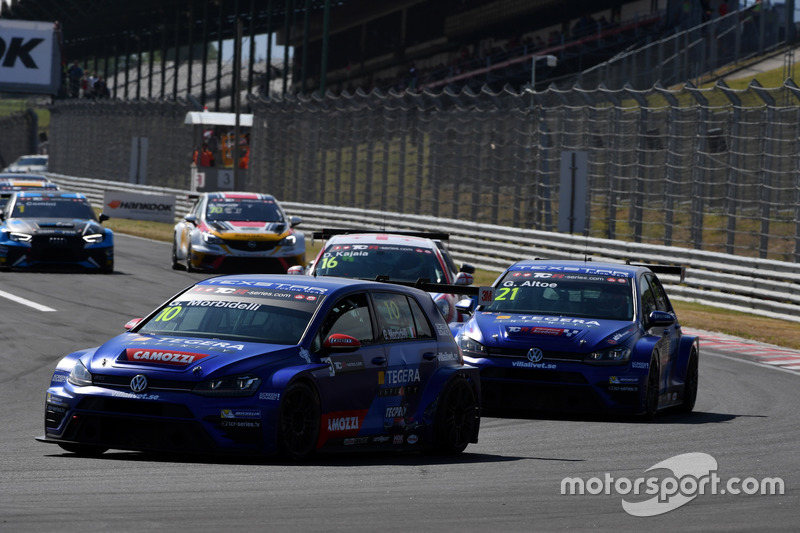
[38,274,480,459]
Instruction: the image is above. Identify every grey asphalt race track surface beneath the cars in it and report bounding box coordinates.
[0,236,800,532]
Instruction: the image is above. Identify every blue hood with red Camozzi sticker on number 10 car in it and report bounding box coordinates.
[87,333,309,380]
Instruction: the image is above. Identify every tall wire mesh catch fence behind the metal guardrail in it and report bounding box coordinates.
[39,80,800,263]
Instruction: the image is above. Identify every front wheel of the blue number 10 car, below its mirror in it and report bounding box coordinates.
[278,382,322,461]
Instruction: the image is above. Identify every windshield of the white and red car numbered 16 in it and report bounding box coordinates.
[315,244,447,283]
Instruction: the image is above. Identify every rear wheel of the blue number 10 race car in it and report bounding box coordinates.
[433,377,479,455]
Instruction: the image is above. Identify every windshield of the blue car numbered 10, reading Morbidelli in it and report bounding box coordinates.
[136,285,324,345]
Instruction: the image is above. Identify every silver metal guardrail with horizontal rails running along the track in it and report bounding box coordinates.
[43,174,800,322]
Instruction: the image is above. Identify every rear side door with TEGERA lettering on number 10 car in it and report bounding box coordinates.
[372,291,438,444]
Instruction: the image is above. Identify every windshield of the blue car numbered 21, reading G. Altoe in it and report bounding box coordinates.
[483,271,633,320]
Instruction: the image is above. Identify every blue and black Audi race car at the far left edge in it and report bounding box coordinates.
[0,189,114,273]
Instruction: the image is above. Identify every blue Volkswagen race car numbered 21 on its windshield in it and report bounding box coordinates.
[453,260,699,417]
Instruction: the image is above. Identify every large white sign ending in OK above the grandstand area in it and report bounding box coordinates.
[0,19,61,95]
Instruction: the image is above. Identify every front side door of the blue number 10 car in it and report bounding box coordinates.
[312,292,386,445]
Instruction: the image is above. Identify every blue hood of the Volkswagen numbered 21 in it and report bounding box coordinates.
[461,312,637,352]
